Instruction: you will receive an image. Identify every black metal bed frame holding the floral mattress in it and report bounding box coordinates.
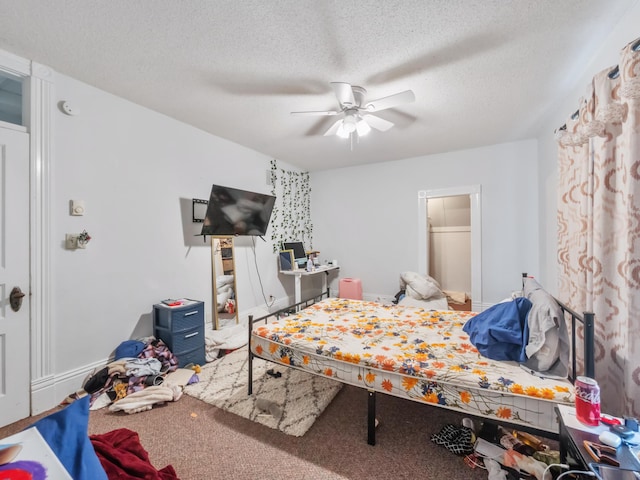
[247,282,595,445]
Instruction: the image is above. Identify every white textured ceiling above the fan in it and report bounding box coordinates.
[0,0,637,171]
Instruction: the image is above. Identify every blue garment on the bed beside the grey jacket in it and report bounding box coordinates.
[462,297,531,363]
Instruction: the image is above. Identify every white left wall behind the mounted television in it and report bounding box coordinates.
[51,75,293,380]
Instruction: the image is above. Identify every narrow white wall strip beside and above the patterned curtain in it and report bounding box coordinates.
[538,1,640,294]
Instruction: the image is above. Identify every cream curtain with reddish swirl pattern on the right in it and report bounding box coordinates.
[557,39,640,417]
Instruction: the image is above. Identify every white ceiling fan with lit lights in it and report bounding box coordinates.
[291,82,416,138]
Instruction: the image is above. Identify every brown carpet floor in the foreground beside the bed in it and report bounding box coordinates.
[0,385,557,480]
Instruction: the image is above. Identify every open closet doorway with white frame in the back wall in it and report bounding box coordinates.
[418,185,482,312]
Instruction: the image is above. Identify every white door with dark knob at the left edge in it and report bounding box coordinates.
[0,127,30,426]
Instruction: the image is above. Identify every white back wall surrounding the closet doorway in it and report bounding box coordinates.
[311,140,539,303]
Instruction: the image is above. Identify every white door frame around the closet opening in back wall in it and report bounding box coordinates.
[418,185,482,312]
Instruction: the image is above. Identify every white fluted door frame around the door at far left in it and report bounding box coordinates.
[0,50,54,415]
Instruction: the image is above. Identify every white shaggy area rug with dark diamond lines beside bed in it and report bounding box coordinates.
[184,346,342,437]
